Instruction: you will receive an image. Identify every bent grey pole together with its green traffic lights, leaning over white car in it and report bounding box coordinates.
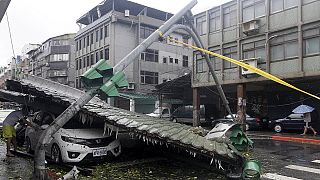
[33,0,197,180]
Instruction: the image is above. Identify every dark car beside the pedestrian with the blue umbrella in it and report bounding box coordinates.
[268,114,304,133]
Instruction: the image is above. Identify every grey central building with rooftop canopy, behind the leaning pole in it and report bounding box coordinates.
[75,0,192,111]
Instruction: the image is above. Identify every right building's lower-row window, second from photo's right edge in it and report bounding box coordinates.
[271,33,298,61]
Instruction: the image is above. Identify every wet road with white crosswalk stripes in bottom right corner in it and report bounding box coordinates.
[254,140,320,180]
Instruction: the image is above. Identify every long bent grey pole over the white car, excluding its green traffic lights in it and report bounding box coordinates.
[33,0,197,180]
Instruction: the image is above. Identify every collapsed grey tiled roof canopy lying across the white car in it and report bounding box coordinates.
[0,75,243,175]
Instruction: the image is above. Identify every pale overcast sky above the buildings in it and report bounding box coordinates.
[0,0,230,66]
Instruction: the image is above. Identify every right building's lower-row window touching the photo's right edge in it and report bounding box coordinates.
[303,28,320,56]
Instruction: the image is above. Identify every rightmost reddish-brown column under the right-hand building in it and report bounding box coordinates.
[236,84,247,131]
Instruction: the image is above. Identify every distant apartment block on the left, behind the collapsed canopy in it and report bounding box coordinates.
[27,34,75,87]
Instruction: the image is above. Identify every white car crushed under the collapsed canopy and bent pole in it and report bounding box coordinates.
[25,112,121,163]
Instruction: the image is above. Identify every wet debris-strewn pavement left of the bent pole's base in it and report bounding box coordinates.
[0,139,33,180]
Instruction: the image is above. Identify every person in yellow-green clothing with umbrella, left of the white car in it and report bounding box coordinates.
[3,108,31,157]
